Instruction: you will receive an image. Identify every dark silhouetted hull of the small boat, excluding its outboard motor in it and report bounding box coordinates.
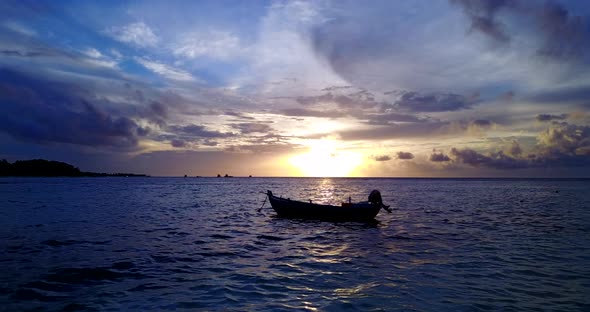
[266,191,381,222]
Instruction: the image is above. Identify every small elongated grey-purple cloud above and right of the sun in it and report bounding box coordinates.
[394,91,476,112]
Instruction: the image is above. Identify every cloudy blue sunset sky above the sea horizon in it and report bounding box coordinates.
[0,0,590,177]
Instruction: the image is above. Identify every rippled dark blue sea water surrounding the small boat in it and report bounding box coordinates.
[0,178,590,311]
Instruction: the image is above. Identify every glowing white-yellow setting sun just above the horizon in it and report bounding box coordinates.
[288,139,363,177]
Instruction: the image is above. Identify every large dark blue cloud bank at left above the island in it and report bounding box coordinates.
[0,69,148,148]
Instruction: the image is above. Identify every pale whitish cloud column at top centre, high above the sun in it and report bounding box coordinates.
[245,1,345,92]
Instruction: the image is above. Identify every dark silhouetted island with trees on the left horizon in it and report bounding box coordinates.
[0,159,147,177]
